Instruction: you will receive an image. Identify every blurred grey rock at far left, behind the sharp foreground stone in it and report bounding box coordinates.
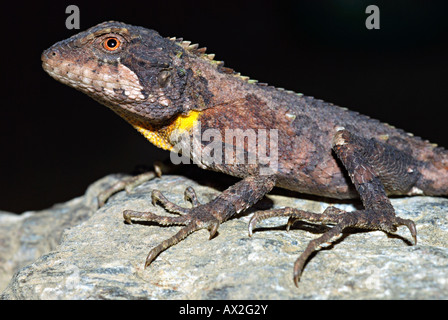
[0,177,107,292]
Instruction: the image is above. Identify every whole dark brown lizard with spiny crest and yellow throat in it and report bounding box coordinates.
[41,21,448,286]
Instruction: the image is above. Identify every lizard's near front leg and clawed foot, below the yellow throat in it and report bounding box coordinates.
[123,176,275,268]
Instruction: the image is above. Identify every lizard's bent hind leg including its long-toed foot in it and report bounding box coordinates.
[249,129,417,286]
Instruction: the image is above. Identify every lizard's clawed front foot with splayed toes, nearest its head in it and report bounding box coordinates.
[123,187,221,268]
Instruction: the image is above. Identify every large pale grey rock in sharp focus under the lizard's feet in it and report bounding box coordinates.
[0,175,448,299]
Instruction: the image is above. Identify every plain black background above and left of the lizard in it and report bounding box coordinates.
[0,0,448,213]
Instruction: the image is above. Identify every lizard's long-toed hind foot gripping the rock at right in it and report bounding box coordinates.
[249,206,417,286]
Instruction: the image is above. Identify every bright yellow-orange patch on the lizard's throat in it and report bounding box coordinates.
[117,111,201,151]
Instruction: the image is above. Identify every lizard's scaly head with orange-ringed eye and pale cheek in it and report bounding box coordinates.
[42,22,200,124]
